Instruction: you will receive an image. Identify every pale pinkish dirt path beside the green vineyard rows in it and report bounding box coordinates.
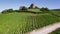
[27,22,60,34]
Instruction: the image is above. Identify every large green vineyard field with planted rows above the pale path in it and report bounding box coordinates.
[0,11,60,34]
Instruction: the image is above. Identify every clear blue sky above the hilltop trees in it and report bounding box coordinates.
[0,0,60,11]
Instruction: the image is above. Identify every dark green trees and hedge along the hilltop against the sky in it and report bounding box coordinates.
[1,4,49,14]
